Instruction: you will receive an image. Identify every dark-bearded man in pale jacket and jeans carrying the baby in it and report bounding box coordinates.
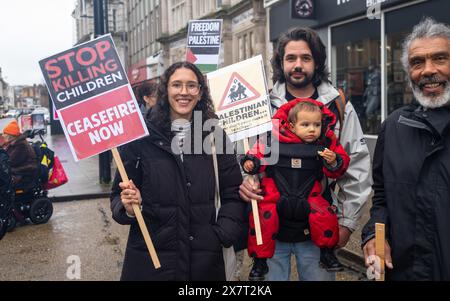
[240,28,371,280]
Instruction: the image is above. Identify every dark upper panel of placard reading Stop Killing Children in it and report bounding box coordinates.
[40,35,127,110]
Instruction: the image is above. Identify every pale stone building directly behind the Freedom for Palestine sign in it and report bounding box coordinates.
[160,0,267,73]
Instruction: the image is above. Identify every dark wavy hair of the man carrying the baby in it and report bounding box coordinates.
[271,27,331,87]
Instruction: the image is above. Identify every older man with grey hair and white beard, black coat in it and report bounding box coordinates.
[362,19,450,281]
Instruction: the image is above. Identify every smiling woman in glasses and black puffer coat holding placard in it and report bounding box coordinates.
[111,62,245,281]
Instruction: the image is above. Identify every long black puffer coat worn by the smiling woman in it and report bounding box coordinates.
[111,119,245,280]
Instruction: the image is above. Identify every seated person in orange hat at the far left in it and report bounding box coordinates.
[3,120,38,190]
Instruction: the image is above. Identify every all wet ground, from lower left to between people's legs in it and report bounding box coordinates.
[0,119,370,281]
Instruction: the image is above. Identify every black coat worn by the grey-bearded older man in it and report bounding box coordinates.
[362,106,450,281]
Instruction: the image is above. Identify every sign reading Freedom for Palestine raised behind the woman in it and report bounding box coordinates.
[186,20,222,73]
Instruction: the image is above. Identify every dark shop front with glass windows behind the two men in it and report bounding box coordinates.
[269,0,450,152]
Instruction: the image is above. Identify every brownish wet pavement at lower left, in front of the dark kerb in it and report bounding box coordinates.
[0,199,129,281]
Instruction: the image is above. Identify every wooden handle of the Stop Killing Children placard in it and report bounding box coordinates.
[111,147,161,269]
